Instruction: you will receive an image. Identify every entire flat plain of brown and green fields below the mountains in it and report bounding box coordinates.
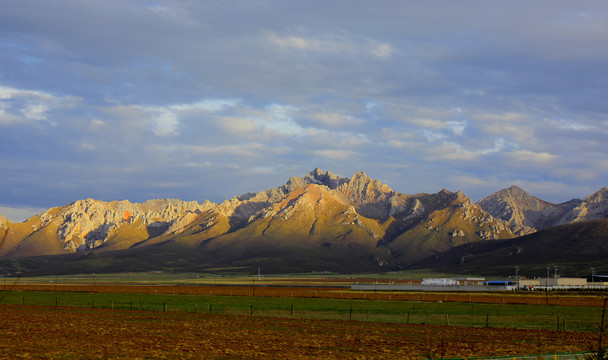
[0,273,604,359]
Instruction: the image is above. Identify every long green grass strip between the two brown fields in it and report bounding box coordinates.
[0,291,602,332]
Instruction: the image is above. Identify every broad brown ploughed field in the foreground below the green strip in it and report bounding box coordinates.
[0,305,596,359]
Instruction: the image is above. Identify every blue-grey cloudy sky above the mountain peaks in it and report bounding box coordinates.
[0,0,608,221]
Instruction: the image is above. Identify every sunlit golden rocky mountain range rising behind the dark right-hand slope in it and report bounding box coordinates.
[0,169,608,272]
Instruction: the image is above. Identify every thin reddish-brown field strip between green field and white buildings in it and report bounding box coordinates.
[6,284,604,307]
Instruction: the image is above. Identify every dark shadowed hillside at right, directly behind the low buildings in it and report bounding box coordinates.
[412,219,608,277]
